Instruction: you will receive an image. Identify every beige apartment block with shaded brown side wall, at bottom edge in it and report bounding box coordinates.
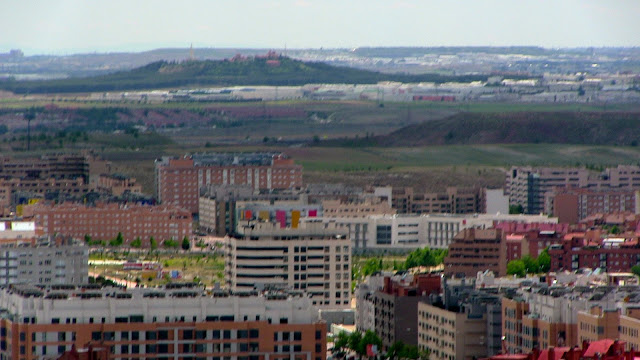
[418,302,487,360]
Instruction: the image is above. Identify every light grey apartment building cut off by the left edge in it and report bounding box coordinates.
[0,243,89,286]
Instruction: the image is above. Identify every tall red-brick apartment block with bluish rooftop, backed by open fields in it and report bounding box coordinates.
[155,153,302,213]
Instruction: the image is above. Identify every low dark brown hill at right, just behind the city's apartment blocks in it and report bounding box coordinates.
[354,112,640,146]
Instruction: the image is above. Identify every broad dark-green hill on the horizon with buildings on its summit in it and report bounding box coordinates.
[0,56,498,94]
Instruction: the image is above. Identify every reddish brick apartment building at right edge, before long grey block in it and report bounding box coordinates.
[545,188,640,224]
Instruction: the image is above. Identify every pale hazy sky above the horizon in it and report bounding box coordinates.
[0,0,640,55]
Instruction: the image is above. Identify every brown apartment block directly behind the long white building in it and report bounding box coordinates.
[392,187,484,214]
